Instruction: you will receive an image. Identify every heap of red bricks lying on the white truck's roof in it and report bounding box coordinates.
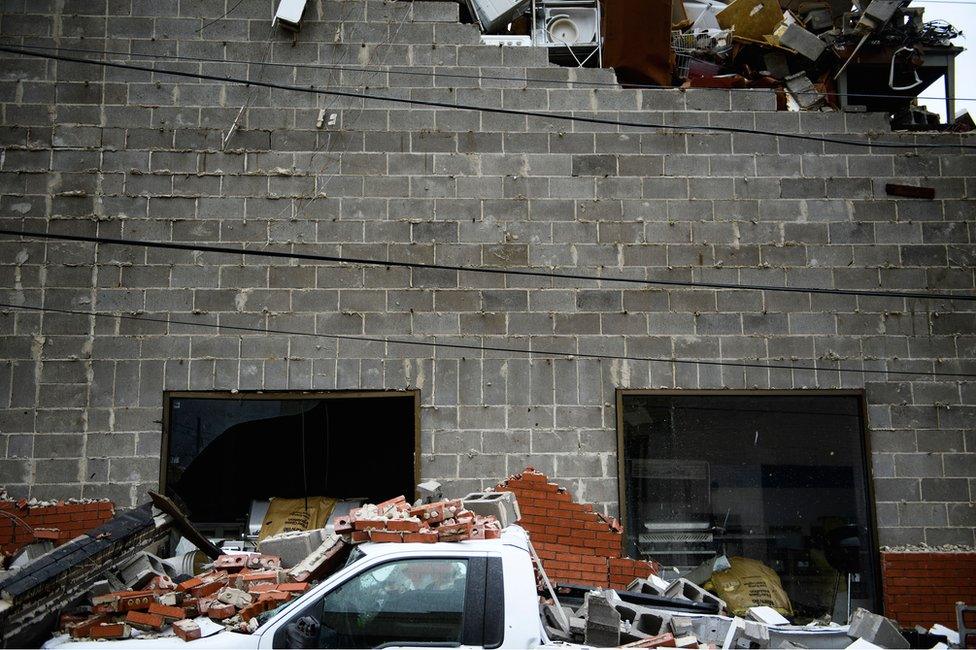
[333,496,502,544]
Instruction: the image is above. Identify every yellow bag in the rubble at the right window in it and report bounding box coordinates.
[702,557,793,616]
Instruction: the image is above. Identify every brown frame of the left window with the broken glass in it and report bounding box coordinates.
[159,388,421,498]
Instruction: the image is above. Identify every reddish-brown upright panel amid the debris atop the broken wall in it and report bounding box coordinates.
[603,0,674,86]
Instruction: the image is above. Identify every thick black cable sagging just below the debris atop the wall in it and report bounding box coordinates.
[0,45,976,150]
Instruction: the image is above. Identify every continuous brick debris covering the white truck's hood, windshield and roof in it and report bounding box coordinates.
[54,493,508,641]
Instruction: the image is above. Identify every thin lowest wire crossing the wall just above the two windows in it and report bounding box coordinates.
[0,302,976,379]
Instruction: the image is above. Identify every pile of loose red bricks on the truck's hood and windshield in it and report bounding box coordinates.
[61,539,316,641]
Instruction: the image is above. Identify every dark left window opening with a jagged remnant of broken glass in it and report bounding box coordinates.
[160,391,419,536]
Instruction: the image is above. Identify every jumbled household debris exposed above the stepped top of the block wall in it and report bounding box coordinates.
[465,0,960,126]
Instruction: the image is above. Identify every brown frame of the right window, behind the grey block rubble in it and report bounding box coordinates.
[615,388,884,604]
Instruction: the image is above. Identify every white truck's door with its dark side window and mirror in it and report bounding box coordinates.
[273,556,491,648]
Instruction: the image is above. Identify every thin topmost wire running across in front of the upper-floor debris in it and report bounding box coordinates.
[3,42,976,101]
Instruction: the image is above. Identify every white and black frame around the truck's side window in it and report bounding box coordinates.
[260,553,488,648]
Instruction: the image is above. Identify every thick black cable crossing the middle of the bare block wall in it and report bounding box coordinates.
[0,228,976,301]
